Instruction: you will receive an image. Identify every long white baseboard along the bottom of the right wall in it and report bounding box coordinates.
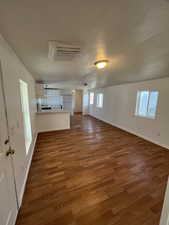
[89,114,169,150]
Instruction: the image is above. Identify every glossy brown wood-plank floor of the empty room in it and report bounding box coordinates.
[17,115,169,225]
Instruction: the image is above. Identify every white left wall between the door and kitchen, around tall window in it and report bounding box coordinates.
[0,35,36,206]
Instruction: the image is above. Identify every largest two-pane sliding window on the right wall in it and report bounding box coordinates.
[135,91,159,119]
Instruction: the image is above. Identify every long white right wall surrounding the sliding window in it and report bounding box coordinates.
[89,78,169,148]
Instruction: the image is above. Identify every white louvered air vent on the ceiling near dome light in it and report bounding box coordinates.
[48,41,80,61]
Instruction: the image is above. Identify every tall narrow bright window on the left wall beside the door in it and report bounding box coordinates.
[19,80,32,154]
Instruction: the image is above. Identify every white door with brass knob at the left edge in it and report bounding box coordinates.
[0,68,18,225]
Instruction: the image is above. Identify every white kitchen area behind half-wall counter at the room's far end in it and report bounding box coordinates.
[36,83,82,132]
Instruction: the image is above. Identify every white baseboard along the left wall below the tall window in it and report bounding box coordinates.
[18,133,38,208]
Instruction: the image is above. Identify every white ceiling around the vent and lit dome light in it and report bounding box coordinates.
[0,0,169,88]
